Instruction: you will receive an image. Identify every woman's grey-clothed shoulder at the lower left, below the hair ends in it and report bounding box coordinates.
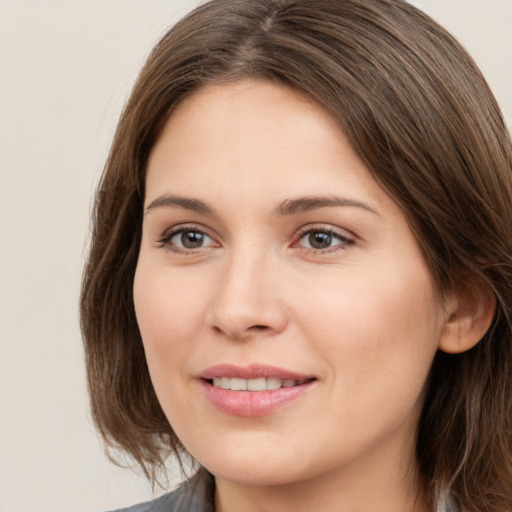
[106,471,215,512]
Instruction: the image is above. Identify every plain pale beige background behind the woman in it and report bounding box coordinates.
[0,0,512,512]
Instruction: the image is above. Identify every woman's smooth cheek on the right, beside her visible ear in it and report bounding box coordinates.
[296,265,442,388]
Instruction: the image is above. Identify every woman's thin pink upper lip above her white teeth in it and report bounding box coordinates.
[199,363,315,381]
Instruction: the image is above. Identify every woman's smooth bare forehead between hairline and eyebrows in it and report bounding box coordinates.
[147,80,388,210]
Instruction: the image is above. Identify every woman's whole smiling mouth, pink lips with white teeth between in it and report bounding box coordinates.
[199,364,316,417]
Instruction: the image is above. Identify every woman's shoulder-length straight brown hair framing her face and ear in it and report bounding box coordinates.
[81,0,512,512]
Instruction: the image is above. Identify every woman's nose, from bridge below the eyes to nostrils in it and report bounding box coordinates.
[211,247,288,341]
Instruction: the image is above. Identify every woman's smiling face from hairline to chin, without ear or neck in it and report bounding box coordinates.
[134,81,444,485]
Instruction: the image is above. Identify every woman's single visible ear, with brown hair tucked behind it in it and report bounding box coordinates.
[439,282,496,354]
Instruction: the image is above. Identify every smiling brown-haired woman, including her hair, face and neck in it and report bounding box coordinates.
[81,0,512,512]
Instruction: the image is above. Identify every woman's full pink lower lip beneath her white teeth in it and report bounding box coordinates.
[200,380,315,417]
